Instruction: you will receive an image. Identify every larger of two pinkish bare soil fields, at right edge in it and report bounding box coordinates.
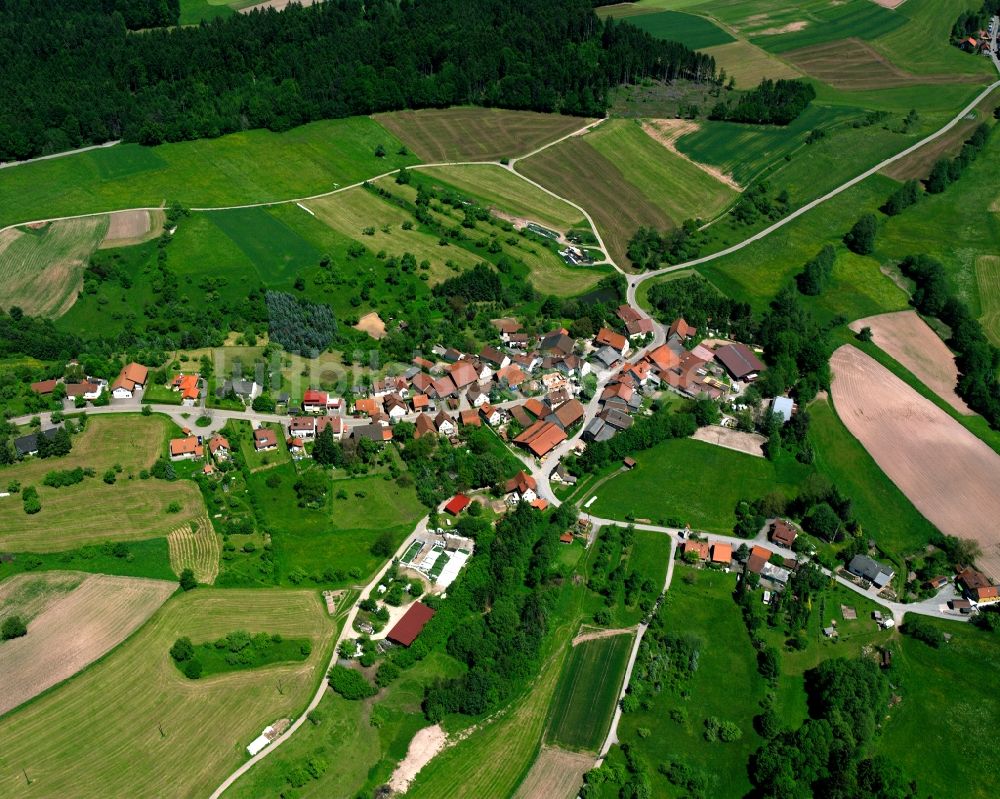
[830,344,1000,579]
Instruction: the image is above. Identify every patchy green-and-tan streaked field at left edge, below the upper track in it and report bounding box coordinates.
[0,216,108,317]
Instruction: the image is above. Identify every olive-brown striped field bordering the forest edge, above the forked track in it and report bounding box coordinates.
[372,107,593,162]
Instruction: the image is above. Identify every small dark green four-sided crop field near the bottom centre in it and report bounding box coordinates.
[547,634,633,752]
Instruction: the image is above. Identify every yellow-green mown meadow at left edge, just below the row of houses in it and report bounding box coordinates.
[0,414,205,552]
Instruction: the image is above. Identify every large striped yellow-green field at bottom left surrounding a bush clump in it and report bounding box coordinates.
[0,589,334,799]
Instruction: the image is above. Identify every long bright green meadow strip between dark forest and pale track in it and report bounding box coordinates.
[0,117,417,231]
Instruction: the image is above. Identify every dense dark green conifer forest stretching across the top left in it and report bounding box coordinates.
[0,0,715,161]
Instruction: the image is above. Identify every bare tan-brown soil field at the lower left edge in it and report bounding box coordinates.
[0,572,177,715]
